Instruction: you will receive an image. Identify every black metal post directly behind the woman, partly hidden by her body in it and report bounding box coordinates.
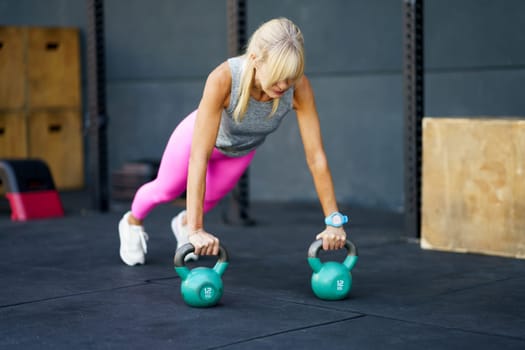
[223,0,254,225]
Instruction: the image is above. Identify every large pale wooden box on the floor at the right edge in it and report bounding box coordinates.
[421,118,525,259]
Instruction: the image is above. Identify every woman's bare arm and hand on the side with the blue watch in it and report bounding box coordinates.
[294,76,346,249]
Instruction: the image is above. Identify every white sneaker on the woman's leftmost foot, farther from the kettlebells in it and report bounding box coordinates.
[118,211,149,266]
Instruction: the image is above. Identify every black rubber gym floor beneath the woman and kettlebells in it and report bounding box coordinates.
[0,193,525,350]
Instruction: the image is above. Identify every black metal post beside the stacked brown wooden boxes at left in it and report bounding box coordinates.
[87,0,109,212]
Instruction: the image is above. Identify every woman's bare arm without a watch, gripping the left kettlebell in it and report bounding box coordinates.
[186,63,231,255]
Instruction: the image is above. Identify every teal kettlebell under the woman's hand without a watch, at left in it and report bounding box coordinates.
[173,243,228,307]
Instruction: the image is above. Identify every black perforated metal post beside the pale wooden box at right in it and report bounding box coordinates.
[403,0,424,239]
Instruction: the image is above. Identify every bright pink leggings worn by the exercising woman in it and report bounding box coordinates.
[131,111,255,220]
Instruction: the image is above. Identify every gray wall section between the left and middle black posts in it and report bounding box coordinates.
[105,0,227,174]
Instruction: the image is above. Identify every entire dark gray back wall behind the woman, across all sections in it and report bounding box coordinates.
[0,0,525,212]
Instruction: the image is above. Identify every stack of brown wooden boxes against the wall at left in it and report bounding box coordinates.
[0,25,84,190]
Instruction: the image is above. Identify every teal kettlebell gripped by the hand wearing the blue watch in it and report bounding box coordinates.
[308,239,357,300]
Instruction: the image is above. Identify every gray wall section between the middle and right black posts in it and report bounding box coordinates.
[248,0,403,210]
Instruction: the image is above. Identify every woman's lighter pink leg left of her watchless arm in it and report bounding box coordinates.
[131,111,197,221]
